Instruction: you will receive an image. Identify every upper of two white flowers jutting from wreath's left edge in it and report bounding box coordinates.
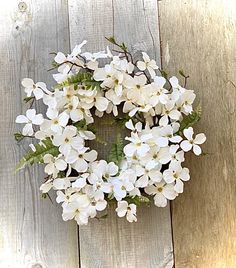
[21,78,50,100]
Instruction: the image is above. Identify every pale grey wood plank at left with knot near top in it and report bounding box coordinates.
[0,0,78,268]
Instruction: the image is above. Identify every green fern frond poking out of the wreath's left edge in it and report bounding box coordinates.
[16,138,59,171]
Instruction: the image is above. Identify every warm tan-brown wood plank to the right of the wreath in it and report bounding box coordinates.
[159,0,236,268]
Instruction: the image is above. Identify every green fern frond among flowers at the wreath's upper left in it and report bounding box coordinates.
[55,72,101,90]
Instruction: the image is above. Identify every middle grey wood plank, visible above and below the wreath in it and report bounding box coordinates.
[69,0,173,268]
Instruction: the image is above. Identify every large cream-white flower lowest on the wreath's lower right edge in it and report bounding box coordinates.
[144,181,178,207]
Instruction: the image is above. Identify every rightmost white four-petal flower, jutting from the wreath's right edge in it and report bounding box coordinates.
[180,127,206,155]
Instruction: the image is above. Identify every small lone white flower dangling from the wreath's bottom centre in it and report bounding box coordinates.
[116,201,137,222]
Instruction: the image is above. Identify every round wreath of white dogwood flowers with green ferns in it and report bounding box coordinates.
[15,37,206,225]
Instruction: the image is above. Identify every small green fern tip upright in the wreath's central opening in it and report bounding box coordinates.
[108,134,124,165]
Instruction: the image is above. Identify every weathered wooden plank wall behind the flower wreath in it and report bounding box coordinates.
[0,0,236,268]
